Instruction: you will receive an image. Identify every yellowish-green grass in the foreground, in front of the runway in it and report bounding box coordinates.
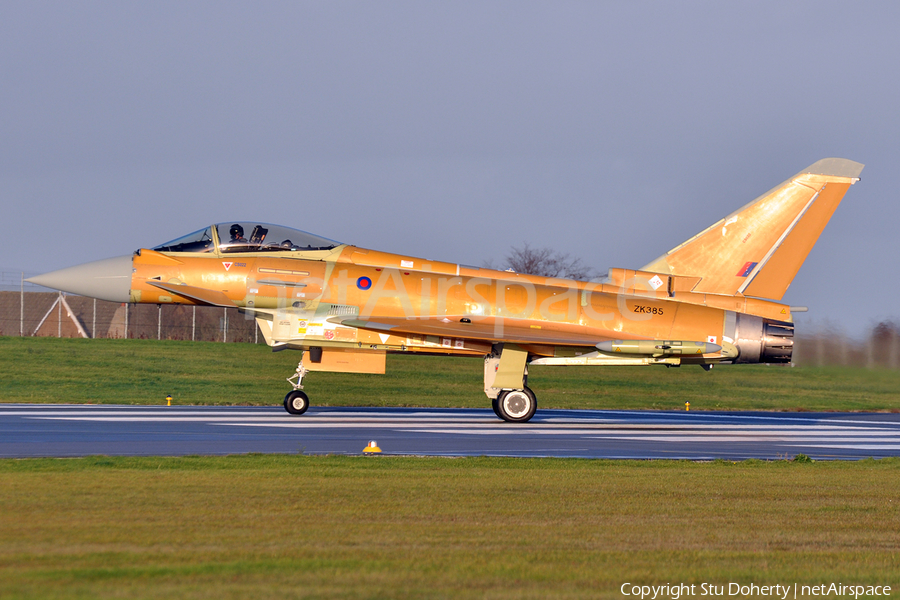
[0,455,900,600]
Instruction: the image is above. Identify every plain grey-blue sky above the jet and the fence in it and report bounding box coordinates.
[0,0,900,335]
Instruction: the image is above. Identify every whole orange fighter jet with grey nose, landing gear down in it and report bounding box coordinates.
[29,158,863,422]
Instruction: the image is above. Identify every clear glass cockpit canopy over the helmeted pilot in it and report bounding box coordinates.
[153,221,340,253]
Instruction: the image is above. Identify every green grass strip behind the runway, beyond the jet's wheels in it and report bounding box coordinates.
[0,337,900,411]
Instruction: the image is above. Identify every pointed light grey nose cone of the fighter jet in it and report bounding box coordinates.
[26,255,132,302]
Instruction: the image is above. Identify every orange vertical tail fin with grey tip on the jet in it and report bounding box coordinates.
[641,158,863,300]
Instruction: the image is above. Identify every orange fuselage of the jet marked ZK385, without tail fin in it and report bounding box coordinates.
[24,223,790,365]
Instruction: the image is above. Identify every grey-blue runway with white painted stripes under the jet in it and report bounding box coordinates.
[0,404,900,460]
